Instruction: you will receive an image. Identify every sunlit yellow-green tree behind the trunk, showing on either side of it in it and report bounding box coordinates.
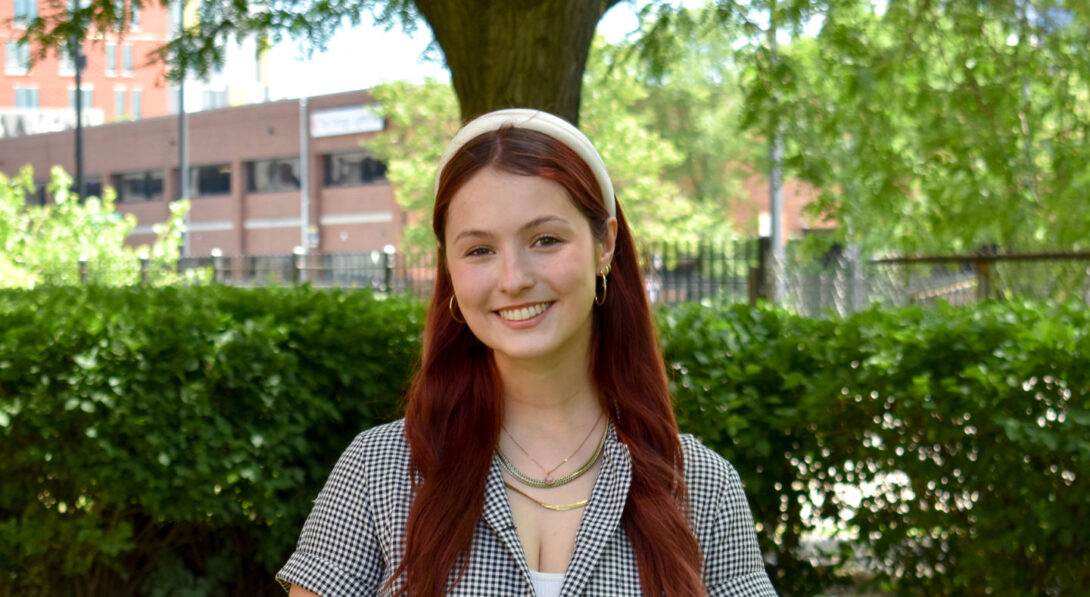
[367,37,710,249]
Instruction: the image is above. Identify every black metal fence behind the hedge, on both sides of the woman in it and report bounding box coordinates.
[19,240,1090,316]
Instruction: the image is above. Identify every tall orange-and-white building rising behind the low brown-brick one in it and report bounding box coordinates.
[0,0,269,138]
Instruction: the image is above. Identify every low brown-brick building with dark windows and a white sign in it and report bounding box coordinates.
[0,92,404,256]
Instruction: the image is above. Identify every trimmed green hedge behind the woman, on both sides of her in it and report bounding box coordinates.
[0,287,1090,596]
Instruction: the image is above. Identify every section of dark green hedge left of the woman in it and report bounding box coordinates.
[0,287,422,595]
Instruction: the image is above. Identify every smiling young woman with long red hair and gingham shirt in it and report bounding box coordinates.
[278,110,775,597]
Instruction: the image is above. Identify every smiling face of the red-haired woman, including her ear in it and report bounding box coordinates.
[444,168,617,368]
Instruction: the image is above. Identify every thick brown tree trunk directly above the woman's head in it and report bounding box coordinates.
[416,0,619,124]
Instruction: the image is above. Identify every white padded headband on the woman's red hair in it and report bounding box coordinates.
[435,108,617,217]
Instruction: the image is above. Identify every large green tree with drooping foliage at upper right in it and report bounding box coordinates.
[732,0,1090,253]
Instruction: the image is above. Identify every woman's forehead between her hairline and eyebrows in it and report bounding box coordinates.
[444,168,585,239]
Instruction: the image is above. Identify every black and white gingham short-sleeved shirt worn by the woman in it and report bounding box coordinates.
[277,421,776,597]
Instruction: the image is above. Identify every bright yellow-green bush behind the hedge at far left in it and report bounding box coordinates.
[0,167,196,288]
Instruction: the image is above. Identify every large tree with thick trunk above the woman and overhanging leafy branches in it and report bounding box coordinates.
[23,0,619,122]
